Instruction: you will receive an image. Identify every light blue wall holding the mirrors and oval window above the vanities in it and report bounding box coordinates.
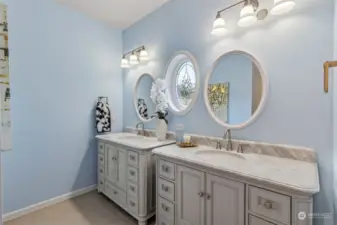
[123,0,334,225]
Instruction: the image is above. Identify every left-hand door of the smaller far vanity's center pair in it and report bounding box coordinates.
[106,145,118,184]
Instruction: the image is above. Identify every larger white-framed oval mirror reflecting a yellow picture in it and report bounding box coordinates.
[204,51,268,129]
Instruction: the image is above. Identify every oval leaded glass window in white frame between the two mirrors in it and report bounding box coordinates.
[166,51,199,115]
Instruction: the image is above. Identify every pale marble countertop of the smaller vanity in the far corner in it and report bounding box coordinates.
[96,133,175,151]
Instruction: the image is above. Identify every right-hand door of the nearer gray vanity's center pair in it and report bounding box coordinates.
[206,174,245,225]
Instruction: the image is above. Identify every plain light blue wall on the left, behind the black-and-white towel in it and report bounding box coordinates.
[2,0,123,213]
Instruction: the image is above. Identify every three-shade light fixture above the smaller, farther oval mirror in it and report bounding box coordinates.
[121,46,149,68]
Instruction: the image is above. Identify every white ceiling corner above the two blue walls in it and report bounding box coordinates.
[57,0,169,29]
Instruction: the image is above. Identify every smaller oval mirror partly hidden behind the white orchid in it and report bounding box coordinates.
[133,73,156,122]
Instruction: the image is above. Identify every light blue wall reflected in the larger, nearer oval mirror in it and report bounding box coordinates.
[209,54,253,124]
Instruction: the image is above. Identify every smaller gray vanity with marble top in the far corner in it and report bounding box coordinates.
[96,133,173,225]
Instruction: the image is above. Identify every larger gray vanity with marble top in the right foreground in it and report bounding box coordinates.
[153,145,319,225]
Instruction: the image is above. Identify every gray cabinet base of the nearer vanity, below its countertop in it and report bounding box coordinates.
[156,155,313,225]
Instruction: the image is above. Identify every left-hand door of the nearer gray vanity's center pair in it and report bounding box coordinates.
[176,166,205,225]
